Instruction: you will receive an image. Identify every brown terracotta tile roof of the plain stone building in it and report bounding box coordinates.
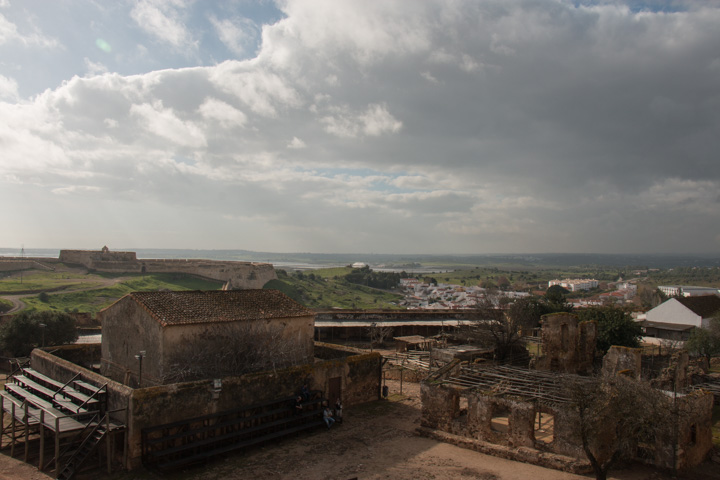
[127,290,315,326]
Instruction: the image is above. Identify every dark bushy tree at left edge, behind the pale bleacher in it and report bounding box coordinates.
[0,311,77,357]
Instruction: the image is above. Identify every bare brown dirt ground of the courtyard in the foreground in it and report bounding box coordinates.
[0,381,720,480]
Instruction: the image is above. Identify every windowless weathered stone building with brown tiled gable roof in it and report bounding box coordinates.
[98,290,315,386]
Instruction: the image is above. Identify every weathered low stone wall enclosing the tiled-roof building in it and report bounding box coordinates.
[32,345,381,468]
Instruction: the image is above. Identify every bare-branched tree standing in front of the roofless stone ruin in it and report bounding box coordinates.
[570,376,676,480]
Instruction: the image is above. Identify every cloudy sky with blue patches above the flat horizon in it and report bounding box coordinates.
[0,0,720,254]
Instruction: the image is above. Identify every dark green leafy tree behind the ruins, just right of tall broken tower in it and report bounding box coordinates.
[577,307,642,354]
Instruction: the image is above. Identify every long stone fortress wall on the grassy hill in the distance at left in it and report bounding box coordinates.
[60,247,277,290]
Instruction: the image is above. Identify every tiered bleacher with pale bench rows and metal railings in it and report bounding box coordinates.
[0,365,125,480]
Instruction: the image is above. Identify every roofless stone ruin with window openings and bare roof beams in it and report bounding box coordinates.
[419,314,713,473]
